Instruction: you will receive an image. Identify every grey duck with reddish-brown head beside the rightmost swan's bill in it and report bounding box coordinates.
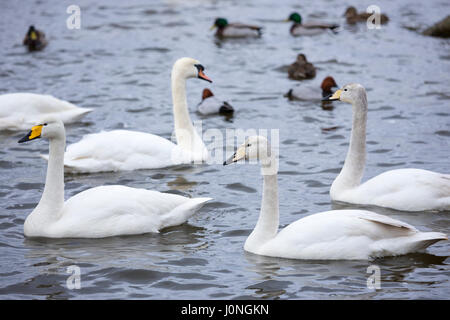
[285,76,338,101]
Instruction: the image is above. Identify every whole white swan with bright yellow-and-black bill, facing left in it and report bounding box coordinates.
[19,118,211,238]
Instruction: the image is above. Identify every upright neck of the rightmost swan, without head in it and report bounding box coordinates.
[332,94,367,189]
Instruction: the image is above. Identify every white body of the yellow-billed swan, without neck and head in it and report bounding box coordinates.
[24,185,210,238]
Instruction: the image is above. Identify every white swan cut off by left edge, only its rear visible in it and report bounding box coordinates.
[0,93,92,130]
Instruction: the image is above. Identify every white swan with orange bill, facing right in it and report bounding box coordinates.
[42,58,212,173]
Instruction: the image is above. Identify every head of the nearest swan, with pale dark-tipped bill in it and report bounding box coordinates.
[223,136,271,166]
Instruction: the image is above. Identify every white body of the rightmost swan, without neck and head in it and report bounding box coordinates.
[330,168,450,211]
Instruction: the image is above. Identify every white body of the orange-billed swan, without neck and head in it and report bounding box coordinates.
[52,130,208,173]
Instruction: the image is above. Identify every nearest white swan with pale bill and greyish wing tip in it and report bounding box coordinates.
[224,136,447,260]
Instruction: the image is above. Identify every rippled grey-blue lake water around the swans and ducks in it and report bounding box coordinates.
[0,0,450,299]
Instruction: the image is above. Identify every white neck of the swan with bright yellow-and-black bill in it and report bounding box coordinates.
[38,137,66,218]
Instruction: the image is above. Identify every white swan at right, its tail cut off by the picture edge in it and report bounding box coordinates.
[325,83,450,211]
